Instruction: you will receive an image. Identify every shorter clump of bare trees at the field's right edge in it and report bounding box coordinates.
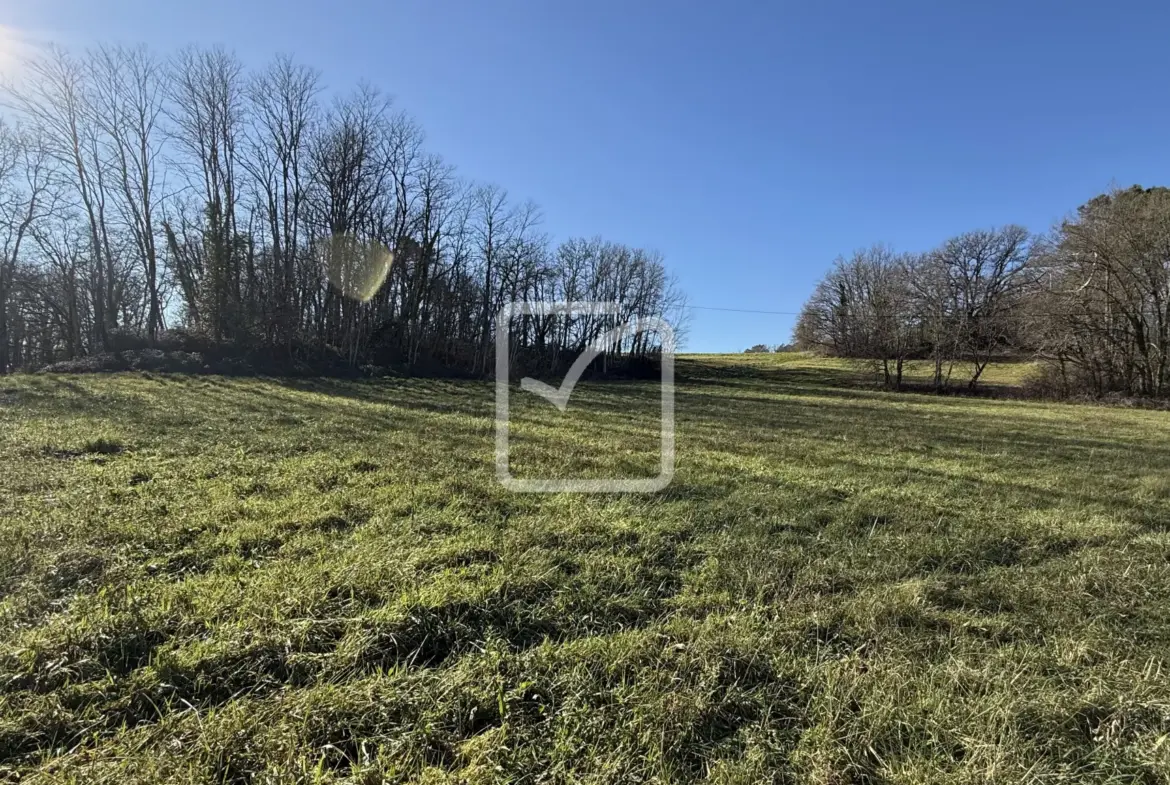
[794,186,1170,398]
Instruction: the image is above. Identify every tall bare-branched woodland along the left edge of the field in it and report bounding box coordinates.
[0,47,683,374]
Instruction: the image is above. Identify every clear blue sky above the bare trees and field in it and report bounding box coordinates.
[0,0,1170,351]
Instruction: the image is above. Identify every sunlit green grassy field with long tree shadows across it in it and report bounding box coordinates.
[0,356,1170,785]
